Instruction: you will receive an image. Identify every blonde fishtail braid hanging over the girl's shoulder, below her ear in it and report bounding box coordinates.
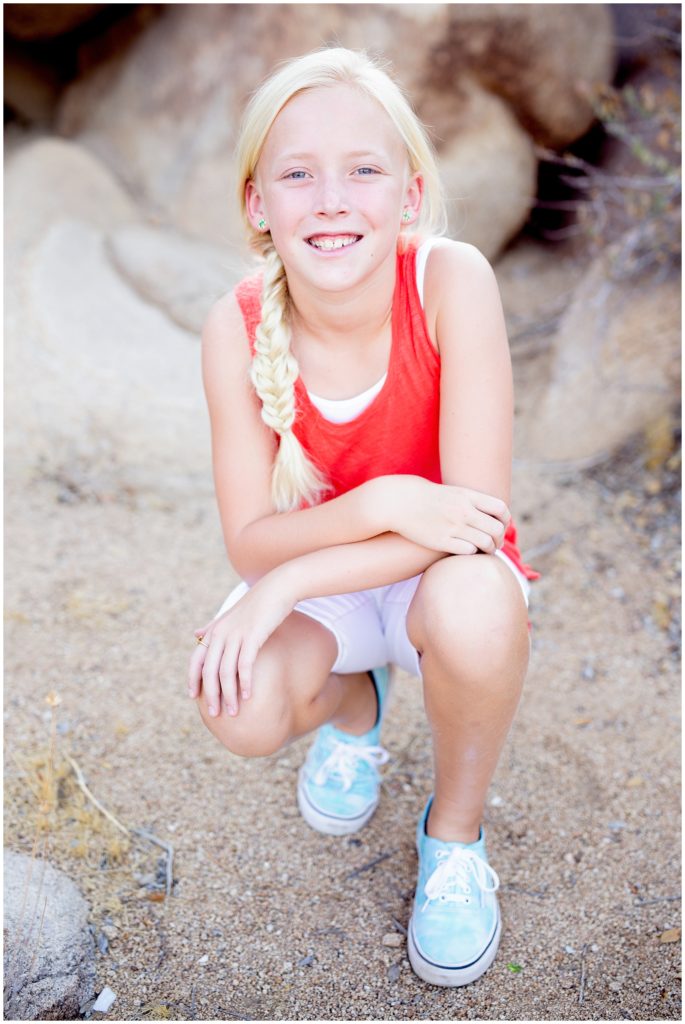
[251,245,328,512]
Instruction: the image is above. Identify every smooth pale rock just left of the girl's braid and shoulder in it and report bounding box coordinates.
[106,224,237,334]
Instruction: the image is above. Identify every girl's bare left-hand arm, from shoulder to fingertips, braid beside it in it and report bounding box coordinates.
[203,295,508,586]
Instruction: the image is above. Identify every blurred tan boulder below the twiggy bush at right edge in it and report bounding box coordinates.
[518,228,681,465]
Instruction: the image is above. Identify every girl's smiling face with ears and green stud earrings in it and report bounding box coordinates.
[240,83,423,291]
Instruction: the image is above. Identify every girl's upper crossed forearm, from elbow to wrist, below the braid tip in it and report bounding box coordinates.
[228,476,410,586]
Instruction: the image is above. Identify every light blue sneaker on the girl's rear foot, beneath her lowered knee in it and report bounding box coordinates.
[297,667,389,836]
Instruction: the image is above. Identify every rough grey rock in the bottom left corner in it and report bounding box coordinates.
[4,850,95,1020]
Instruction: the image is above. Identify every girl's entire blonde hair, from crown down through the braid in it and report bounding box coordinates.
[237,47,446,512]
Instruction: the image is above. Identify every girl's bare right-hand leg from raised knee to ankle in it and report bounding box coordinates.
[408,555,529,843]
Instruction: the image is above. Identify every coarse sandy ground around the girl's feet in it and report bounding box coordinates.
[5,405,681,1020]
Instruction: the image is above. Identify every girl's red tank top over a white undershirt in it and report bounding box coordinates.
[236,235,539,580]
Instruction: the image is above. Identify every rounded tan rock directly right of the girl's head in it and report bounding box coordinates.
[424,80,538,259]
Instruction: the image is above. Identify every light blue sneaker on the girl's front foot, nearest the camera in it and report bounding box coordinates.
[408,797,502,985]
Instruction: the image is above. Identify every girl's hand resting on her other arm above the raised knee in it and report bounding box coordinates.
[384,476,511,555]
